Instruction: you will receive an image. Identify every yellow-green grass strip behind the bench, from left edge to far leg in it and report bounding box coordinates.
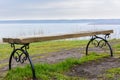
[0,40,87,60]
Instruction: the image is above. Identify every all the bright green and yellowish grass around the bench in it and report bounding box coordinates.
[0,40,120,80]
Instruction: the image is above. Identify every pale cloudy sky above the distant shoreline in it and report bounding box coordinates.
[0,0,120,20]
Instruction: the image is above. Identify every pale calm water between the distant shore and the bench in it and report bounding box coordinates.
[0,23,120,38]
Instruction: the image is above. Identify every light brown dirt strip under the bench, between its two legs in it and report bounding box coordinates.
[33,48,85,63]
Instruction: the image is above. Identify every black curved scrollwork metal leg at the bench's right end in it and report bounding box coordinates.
[86,34,113,56]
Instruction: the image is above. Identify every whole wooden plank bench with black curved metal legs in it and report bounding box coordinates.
[3,30,113,80]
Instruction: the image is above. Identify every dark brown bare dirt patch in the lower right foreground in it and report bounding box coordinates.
[66,57,120,80]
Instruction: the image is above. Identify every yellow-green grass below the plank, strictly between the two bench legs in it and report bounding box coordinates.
[29,40,87,55]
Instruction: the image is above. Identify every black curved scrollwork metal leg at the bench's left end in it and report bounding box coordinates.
[9,44,36,80]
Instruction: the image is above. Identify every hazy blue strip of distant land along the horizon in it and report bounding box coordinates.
[0,19,120,25]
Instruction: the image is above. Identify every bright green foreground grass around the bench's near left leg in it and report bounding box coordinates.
[4,53,106,80]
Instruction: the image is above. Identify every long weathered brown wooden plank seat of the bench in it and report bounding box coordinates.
[3,30,113,44]
